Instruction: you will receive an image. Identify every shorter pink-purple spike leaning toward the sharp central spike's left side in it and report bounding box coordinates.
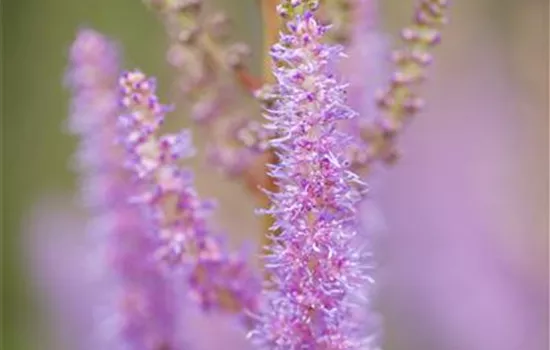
[119,71,260,320]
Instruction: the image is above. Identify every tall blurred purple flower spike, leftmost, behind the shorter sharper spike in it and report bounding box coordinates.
[68,29,179,350]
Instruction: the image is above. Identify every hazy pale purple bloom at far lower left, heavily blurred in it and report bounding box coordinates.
[23,198,99,350]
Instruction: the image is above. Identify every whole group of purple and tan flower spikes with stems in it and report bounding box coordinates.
[62,0,447,350]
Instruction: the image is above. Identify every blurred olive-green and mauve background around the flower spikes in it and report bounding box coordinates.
[1,0,549,350]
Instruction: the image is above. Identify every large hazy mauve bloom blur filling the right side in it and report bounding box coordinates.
[380,19,549,350]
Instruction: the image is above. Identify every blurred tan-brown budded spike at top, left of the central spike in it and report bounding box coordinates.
[144,0,260,176]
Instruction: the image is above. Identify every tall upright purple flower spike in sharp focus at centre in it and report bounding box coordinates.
[250,0,376,350]
